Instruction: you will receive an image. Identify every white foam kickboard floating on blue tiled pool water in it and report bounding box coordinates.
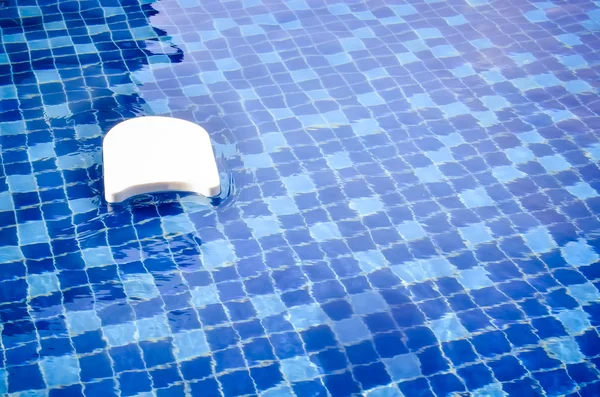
[102,116,221,203]
